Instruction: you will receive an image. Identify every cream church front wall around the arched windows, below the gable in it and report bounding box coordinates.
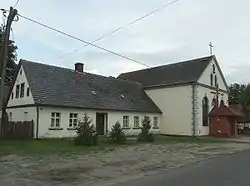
[196,85,228,136]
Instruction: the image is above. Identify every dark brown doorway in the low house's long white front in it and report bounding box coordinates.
[96,113,108,135]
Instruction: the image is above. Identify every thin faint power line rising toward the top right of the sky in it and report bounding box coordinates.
[59,0,180,60]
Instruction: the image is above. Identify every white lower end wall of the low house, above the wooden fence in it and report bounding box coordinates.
[6,107,37,137]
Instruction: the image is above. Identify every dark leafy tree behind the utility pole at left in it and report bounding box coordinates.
[0,25,17,86]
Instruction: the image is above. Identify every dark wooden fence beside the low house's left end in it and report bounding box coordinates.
[1,121,34,139]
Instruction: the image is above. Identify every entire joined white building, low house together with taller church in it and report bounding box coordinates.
[7,56,228,138]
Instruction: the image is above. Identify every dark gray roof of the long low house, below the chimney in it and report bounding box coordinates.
[20,60,161,113]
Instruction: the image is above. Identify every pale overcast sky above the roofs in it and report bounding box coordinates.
[0,0,250,83]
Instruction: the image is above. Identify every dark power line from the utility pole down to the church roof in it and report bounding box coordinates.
[18,14,150,67]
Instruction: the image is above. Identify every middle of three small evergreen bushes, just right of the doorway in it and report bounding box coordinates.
[109,121,126,144]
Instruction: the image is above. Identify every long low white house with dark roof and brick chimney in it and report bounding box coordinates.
[7,60,161,138]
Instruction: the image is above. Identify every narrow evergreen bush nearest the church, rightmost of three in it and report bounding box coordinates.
[138,116,154,142]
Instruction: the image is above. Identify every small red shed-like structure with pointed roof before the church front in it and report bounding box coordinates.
[209,100,240,137]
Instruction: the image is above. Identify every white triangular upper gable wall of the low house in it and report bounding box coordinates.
[7,67,34,107]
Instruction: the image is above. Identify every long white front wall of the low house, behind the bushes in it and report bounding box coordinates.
[39,107,161,138]
